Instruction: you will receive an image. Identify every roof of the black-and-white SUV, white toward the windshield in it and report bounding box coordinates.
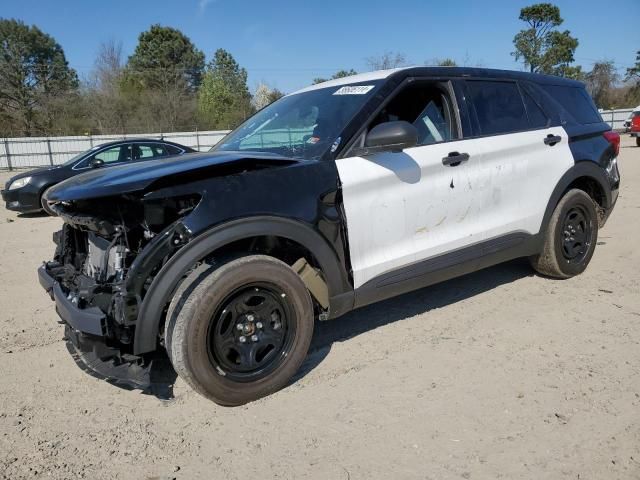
[291,66,582,95]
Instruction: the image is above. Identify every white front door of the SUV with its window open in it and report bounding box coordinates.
[336,81,480,288]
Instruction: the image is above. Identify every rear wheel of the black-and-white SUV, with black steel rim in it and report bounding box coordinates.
[530,189,598,278]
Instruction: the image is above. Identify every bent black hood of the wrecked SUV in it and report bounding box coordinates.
[46,152,298,202]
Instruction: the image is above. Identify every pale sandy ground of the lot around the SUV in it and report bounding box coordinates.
[0,137,640,480]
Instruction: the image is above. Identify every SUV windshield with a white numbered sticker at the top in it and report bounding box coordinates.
[211,81,380,160]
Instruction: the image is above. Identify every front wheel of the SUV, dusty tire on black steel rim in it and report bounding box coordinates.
[165,255,314,406]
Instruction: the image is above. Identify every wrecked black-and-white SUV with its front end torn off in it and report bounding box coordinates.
[39,67,620,405]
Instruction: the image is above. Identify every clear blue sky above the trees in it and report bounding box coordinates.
[0,0,640,92]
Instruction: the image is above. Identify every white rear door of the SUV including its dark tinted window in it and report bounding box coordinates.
[465,80,574,244]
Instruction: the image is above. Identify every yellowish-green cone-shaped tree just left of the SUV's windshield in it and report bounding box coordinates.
[198,49,253,128]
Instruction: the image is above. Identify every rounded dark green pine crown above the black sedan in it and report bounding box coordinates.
[127,24,204,90]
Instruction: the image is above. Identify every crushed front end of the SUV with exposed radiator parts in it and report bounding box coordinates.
[38,195,199,387]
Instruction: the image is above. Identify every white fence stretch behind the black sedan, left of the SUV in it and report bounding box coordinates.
[0,130,228,170]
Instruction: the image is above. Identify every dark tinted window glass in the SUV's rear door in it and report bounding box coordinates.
[467,80,531,135]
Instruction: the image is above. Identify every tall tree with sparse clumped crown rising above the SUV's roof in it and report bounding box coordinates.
[512,3,578,75]
